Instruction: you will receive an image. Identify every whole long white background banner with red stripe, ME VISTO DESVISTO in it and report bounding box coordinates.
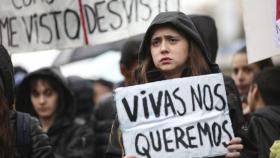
[0,0,192,53]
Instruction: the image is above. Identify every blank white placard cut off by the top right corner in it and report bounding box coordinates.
[243,0,280,63]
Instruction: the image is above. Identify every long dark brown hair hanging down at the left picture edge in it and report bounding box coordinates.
[0,88,15,158]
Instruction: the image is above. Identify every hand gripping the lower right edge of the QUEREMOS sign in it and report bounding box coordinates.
[226,137,243,158]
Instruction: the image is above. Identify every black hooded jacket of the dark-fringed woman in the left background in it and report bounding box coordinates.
[16,68,94,158]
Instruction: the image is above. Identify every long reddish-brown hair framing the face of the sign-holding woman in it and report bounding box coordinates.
[138,24,210,83]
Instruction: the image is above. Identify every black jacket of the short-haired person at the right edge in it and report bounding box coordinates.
[248,106,280,158]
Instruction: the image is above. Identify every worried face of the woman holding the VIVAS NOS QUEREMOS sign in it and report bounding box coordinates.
[150,26,189,79]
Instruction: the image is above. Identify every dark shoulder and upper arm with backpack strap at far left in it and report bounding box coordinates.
[10,111,53,158]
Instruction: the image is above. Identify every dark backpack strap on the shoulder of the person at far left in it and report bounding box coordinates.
[16,112,31,158]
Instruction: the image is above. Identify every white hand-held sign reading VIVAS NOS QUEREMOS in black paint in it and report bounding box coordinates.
[115,73,233,158]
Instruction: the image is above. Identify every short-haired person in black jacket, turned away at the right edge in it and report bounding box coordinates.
[248,66,280,158]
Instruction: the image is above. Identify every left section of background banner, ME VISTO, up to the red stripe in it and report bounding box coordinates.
[0,0,84,53]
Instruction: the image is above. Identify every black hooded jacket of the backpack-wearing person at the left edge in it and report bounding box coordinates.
[0,45,53,158]
